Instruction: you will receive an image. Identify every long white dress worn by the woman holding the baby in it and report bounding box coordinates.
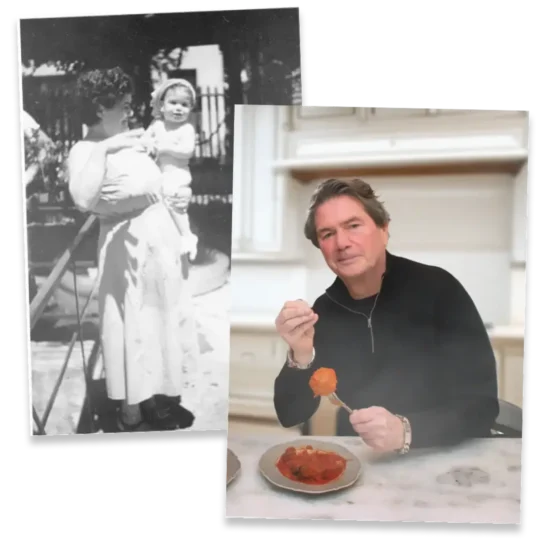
[86,150,199,404]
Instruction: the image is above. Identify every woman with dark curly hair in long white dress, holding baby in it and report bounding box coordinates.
[69,68,198,431]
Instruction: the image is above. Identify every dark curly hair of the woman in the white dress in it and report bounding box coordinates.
[76,67,134,126]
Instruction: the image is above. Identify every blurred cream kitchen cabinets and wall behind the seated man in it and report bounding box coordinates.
[229,105,529,435]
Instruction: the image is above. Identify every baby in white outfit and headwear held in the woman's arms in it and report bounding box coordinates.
[143,78,198,260]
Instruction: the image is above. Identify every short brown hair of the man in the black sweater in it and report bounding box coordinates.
[304,179,390,247]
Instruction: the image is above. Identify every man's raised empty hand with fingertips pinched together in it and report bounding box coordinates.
[276,300,318,365]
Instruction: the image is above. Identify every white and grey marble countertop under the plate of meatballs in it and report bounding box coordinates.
[225,431,522,523]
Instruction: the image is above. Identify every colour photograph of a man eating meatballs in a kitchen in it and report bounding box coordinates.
[225,105,530,527]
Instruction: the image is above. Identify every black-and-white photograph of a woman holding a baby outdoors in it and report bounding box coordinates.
[13,8,303,436]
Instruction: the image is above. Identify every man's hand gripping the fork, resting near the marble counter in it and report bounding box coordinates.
[350,407,405,453]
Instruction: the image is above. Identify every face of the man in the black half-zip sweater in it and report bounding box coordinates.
[315,196,388,280]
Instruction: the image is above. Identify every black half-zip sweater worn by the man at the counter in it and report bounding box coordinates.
[274,252,499,448]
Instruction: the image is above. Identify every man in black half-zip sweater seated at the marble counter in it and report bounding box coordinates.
[274,179,499,453]
